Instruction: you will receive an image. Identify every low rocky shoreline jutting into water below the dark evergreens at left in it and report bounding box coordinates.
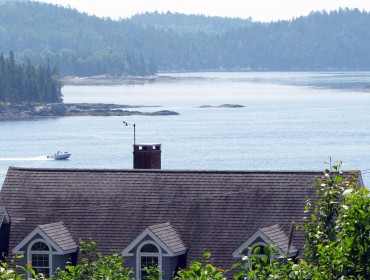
[0,103,179,120]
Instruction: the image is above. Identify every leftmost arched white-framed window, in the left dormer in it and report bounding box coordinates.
[27,240,51,277]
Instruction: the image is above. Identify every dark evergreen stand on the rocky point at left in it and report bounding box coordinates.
[0,51,62,104]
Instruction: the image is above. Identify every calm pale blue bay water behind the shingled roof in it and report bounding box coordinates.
[0,72,370,186]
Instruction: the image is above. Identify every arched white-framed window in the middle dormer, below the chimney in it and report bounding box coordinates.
[138,241,162,280]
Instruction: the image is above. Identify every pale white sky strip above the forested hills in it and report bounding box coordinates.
[38,0,370,22]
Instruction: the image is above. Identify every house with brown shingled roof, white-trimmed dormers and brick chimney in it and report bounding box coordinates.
[0,144,361,279]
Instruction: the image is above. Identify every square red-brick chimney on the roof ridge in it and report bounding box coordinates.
[134,144,162,169]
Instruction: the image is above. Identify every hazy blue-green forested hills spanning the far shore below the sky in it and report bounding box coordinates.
[0,2,370,76]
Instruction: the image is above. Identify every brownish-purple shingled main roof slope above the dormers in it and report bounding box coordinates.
[0,167,360,268]
